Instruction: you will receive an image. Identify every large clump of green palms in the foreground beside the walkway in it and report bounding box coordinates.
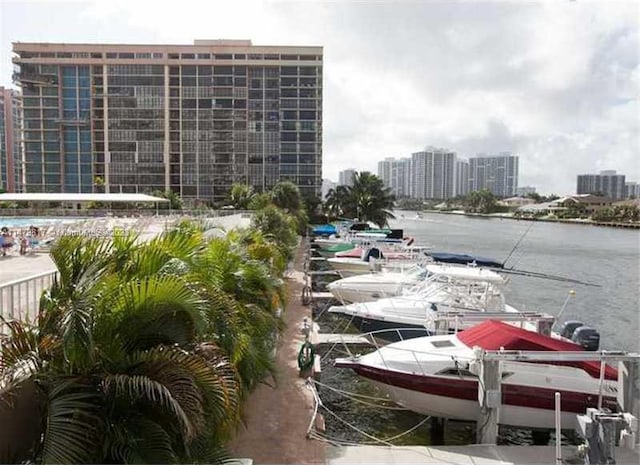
[0,218,290,463]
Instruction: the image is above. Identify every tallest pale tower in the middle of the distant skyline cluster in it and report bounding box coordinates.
[411,147,456,199]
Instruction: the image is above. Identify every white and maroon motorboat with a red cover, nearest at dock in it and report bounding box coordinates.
[335,320,618,429]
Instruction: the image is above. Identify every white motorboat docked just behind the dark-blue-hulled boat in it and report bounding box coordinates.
[328,263,504,303]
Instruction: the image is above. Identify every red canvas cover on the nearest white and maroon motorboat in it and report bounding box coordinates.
[457,320,618,380]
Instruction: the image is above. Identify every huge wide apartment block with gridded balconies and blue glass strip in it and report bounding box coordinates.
[13,40,323,200]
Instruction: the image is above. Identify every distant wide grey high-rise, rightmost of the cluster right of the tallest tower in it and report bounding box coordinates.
[469,152,518,198]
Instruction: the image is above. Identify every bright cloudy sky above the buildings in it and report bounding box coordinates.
[0,0,640,194]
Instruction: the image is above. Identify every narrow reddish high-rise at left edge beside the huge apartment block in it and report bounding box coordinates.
[0,87,22,192]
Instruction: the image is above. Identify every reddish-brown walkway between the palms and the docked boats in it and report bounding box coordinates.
[229,239,325,464]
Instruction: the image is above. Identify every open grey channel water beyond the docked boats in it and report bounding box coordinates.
[392,212,640,351]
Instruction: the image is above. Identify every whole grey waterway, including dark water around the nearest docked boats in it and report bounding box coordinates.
[319,212,640,445]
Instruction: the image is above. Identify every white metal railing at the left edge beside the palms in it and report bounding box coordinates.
[0,270,58,333]
